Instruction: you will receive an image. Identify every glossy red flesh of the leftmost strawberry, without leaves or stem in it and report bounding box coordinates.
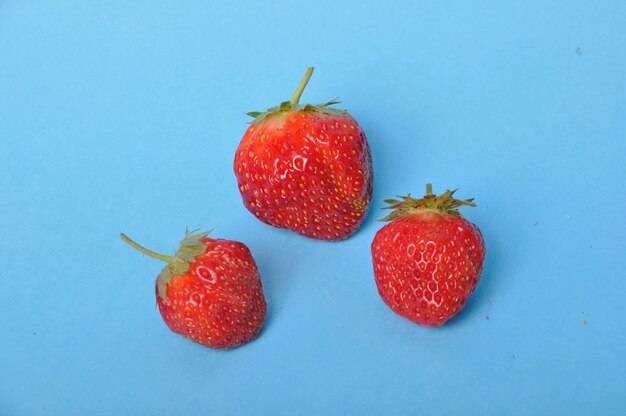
[156,238,267,349]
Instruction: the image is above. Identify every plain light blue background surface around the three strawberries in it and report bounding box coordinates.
[0,0,626,416]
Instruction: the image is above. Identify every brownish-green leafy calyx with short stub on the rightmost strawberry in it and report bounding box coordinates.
[379,184,476,221]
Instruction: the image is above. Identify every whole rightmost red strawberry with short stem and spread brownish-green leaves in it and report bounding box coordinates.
[372,184,485,326]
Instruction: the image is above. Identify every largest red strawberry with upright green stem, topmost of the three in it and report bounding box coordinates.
[234,68,373,240]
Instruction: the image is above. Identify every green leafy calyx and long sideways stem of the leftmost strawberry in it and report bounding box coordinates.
[120,229,211,298]
